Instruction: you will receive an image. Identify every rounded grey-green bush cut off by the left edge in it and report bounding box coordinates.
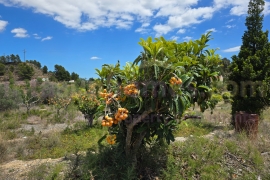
[0,84,22,111]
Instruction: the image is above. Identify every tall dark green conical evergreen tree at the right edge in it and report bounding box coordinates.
[229,0,270,115]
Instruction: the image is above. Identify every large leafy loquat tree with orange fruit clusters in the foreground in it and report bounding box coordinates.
[96,33,220,165]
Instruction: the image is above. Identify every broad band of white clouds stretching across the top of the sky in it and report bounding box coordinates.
[0,0,270,36]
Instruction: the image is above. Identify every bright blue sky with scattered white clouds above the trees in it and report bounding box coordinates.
[0,0,270,79]
